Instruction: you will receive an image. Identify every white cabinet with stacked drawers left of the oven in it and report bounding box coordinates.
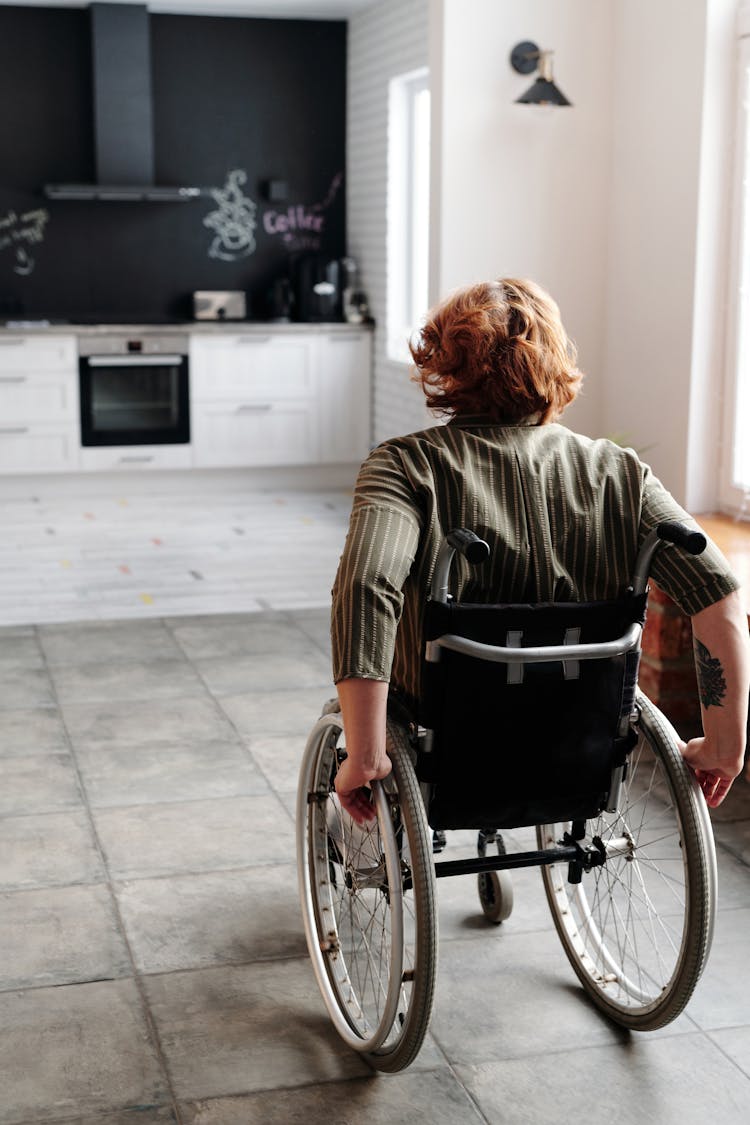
[0,335,80,473]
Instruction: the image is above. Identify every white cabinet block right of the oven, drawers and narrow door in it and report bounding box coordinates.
[190,330,370,468]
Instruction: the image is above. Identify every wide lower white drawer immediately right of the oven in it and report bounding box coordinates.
[192,402,317,468]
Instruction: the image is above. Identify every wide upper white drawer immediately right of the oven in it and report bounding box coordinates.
[190,335,315,402]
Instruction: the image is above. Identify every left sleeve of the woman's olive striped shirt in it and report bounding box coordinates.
[331,446,422,683]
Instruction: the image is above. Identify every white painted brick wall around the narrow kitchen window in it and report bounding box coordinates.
[346,0,434,443]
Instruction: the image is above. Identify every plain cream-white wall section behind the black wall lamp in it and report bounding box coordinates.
[430,0,613,433]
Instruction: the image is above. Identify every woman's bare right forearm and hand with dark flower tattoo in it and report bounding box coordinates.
[683,591,750,808]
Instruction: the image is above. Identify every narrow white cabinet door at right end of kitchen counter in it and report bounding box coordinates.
[318,330,372,465]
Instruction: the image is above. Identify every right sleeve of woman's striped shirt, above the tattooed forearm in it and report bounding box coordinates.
[639,466,740,617]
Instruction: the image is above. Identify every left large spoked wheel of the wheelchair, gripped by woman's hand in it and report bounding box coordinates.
[297,713,437,1071]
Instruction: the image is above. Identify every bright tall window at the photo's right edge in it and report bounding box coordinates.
[722,5,750,514]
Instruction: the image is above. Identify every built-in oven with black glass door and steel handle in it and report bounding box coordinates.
[79,333,190,446]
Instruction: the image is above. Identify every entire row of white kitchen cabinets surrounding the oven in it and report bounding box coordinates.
[0,324,371,474]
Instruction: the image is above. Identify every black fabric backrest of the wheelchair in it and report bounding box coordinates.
[417,594,647,828]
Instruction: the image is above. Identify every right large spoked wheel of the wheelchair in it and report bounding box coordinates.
[536,692,716,1032]
